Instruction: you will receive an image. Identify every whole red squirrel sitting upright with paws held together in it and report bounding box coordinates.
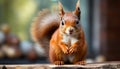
[31,0,87,65]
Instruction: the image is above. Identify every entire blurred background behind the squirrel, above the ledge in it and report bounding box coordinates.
[0,0,120,64]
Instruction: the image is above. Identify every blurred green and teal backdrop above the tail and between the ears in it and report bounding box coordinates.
[0,0,87,40]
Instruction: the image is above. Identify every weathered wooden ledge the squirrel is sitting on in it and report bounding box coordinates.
[0,62,120,69]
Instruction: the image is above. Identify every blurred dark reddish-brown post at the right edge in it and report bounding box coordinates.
[100,0,120,61]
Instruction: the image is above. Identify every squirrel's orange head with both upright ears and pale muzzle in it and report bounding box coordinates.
[59,0,81,35]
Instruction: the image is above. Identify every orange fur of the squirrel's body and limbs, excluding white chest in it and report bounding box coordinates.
[49,27,87,64]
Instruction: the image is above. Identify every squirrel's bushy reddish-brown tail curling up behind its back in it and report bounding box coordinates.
[31,9,60,55]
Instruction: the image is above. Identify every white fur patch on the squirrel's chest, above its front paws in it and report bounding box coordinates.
[62,34,78,47]
